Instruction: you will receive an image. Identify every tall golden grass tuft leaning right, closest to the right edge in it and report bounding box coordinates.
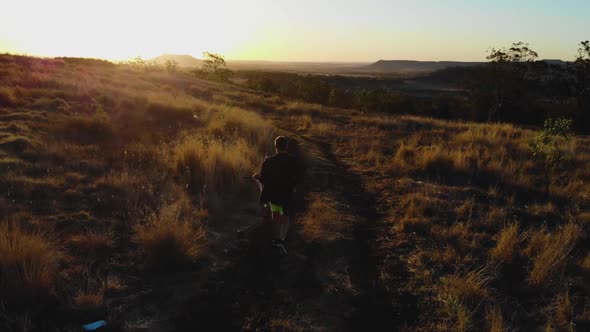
[525,223,581,287]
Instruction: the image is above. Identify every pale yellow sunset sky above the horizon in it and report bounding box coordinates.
[0,0,590,62]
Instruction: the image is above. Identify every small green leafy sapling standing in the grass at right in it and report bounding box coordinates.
[529,118,572,197]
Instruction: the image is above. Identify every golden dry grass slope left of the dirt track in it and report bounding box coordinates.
[0,55,276,330]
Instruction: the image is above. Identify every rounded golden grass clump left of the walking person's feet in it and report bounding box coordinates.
[133,201,206,268]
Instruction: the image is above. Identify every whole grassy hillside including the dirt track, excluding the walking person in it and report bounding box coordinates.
[0,55,590,331]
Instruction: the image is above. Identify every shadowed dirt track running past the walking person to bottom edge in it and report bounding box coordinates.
[132,120,416,331]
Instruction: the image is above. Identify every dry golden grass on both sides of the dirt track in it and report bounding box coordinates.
[0,53,590,331]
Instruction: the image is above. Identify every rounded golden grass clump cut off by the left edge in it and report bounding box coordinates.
[0,222,63,298]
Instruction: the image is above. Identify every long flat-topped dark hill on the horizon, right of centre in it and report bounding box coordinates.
[359,60,482,73]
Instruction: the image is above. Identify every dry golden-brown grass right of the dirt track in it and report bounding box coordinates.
[291,84,590,331]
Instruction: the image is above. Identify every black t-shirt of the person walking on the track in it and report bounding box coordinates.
[260,153,298,207]
